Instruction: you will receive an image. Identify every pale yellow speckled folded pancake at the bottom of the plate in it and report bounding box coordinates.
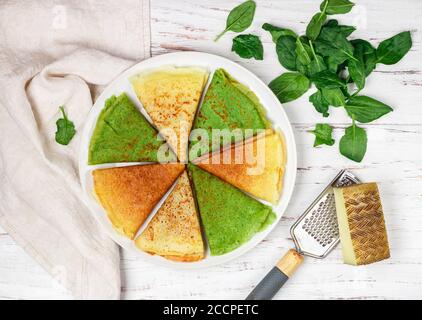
[136,171,204,262]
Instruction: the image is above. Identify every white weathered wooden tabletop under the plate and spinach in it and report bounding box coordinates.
[0,0,422,299]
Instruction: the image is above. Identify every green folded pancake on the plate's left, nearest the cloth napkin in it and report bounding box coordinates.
[88,93,176,165]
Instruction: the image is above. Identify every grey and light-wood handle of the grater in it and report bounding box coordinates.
[246,249,303,300]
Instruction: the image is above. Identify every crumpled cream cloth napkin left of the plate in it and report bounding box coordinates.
[0,0,150,299]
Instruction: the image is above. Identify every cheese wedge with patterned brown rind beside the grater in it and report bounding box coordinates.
[334,183,390,265]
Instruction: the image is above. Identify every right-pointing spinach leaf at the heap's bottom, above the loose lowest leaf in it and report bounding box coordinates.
[345,96,393,123]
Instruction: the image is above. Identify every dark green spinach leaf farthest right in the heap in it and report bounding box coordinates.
[377,31,412,65]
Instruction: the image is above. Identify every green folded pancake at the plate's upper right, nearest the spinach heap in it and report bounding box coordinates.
[189,69,270,160]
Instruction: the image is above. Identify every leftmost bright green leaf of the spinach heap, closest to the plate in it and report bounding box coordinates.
[268,72,311,103]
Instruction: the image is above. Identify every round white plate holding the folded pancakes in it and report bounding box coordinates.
[79,52,297,268]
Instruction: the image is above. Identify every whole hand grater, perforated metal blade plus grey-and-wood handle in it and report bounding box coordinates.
[246,170,360,300]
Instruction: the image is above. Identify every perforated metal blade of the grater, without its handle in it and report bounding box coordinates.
[290,170,360,259]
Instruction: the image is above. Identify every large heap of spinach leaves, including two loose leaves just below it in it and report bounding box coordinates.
[262,0,412,162]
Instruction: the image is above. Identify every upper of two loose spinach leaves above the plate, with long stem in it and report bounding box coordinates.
[214,0,256,41]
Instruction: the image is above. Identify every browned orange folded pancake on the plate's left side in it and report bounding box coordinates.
[92,163,184,239]
